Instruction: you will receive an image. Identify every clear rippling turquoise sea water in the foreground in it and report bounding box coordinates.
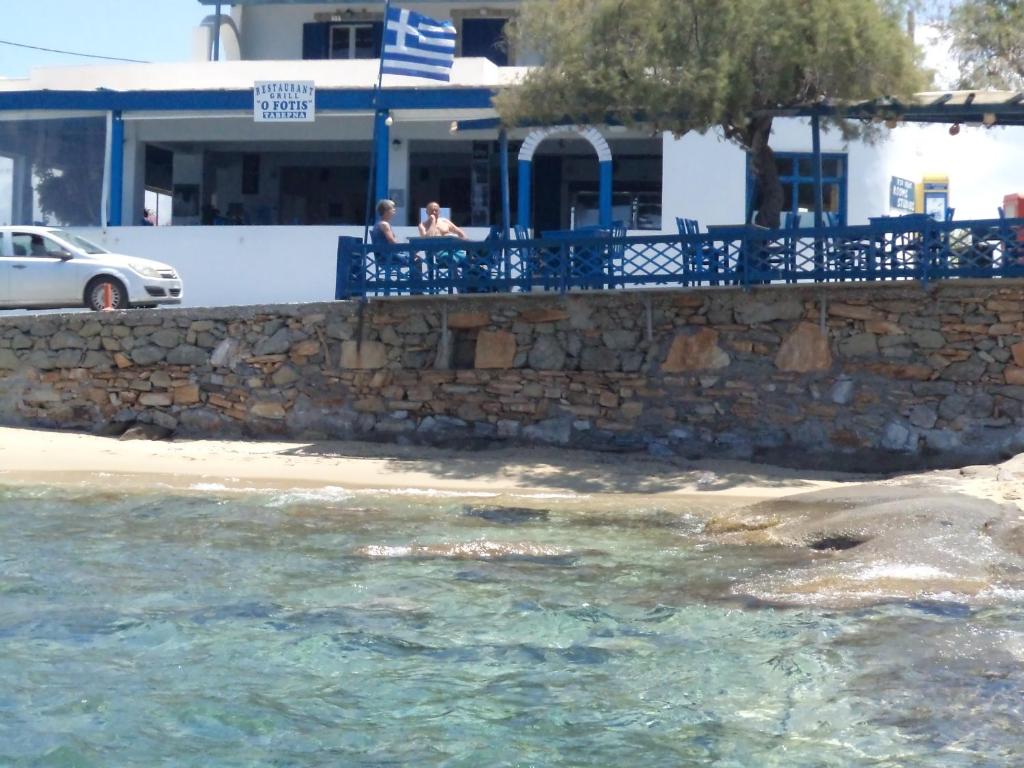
[0,486,1024,768]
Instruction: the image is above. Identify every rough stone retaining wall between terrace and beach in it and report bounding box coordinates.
[0,281,1024,468]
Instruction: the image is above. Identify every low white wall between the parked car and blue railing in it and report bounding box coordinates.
[68,226,487,306]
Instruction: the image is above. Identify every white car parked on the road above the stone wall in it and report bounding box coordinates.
[0,226,181,309]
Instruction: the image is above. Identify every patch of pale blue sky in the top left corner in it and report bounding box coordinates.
[0,0,213,78]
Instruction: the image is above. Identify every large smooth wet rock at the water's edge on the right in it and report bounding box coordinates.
[705,481,1024,606]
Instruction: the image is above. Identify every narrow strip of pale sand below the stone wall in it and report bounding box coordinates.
[0,428,863,502]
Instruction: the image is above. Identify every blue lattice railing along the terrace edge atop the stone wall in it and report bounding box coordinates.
[335,215,1024,298]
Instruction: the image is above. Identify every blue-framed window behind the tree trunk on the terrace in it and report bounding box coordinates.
[746,152,848,226]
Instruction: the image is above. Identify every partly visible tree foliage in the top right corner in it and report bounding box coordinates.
[948,0,1024,90]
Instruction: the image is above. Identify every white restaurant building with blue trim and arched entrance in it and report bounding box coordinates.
[0,0,1024,304]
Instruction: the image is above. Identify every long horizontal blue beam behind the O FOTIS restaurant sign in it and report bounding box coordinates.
[0,87,496,112]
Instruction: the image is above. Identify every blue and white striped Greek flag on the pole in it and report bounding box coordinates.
[381,8,455,82]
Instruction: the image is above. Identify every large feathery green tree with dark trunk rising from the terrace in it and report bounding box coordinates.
[495,0,923,226]
